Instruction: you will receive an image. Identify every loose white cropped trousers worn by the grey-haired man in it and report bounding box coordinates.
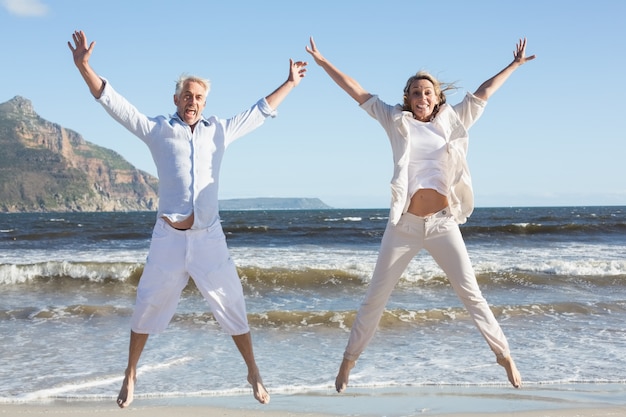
[131,219,250,336]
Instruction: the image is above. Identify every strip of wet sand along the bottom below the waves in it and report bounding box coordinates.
[0,383,626,417]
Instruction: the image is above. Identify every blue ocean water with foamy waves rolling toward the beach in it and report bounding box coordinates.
[0,206,626,403]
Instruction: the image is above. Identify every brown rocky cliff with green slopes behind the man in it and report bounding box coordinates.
[0,96,158,212]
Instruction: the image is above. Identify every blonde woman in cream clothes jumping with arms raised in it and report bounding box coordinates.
[306,38,535,392]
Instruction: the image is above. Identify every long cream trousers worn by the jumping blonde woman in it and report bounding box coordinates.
[344,209,510,361]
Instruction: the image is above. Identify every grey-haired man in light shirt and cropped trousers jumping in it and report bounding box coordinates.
[68,31,307,408]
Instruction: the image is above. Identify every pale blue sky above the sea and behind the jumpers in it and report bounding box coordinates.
[0,0,626,208]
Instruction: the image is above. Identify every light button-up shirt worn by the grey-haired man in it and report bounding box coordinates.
[98,80,276,229]
